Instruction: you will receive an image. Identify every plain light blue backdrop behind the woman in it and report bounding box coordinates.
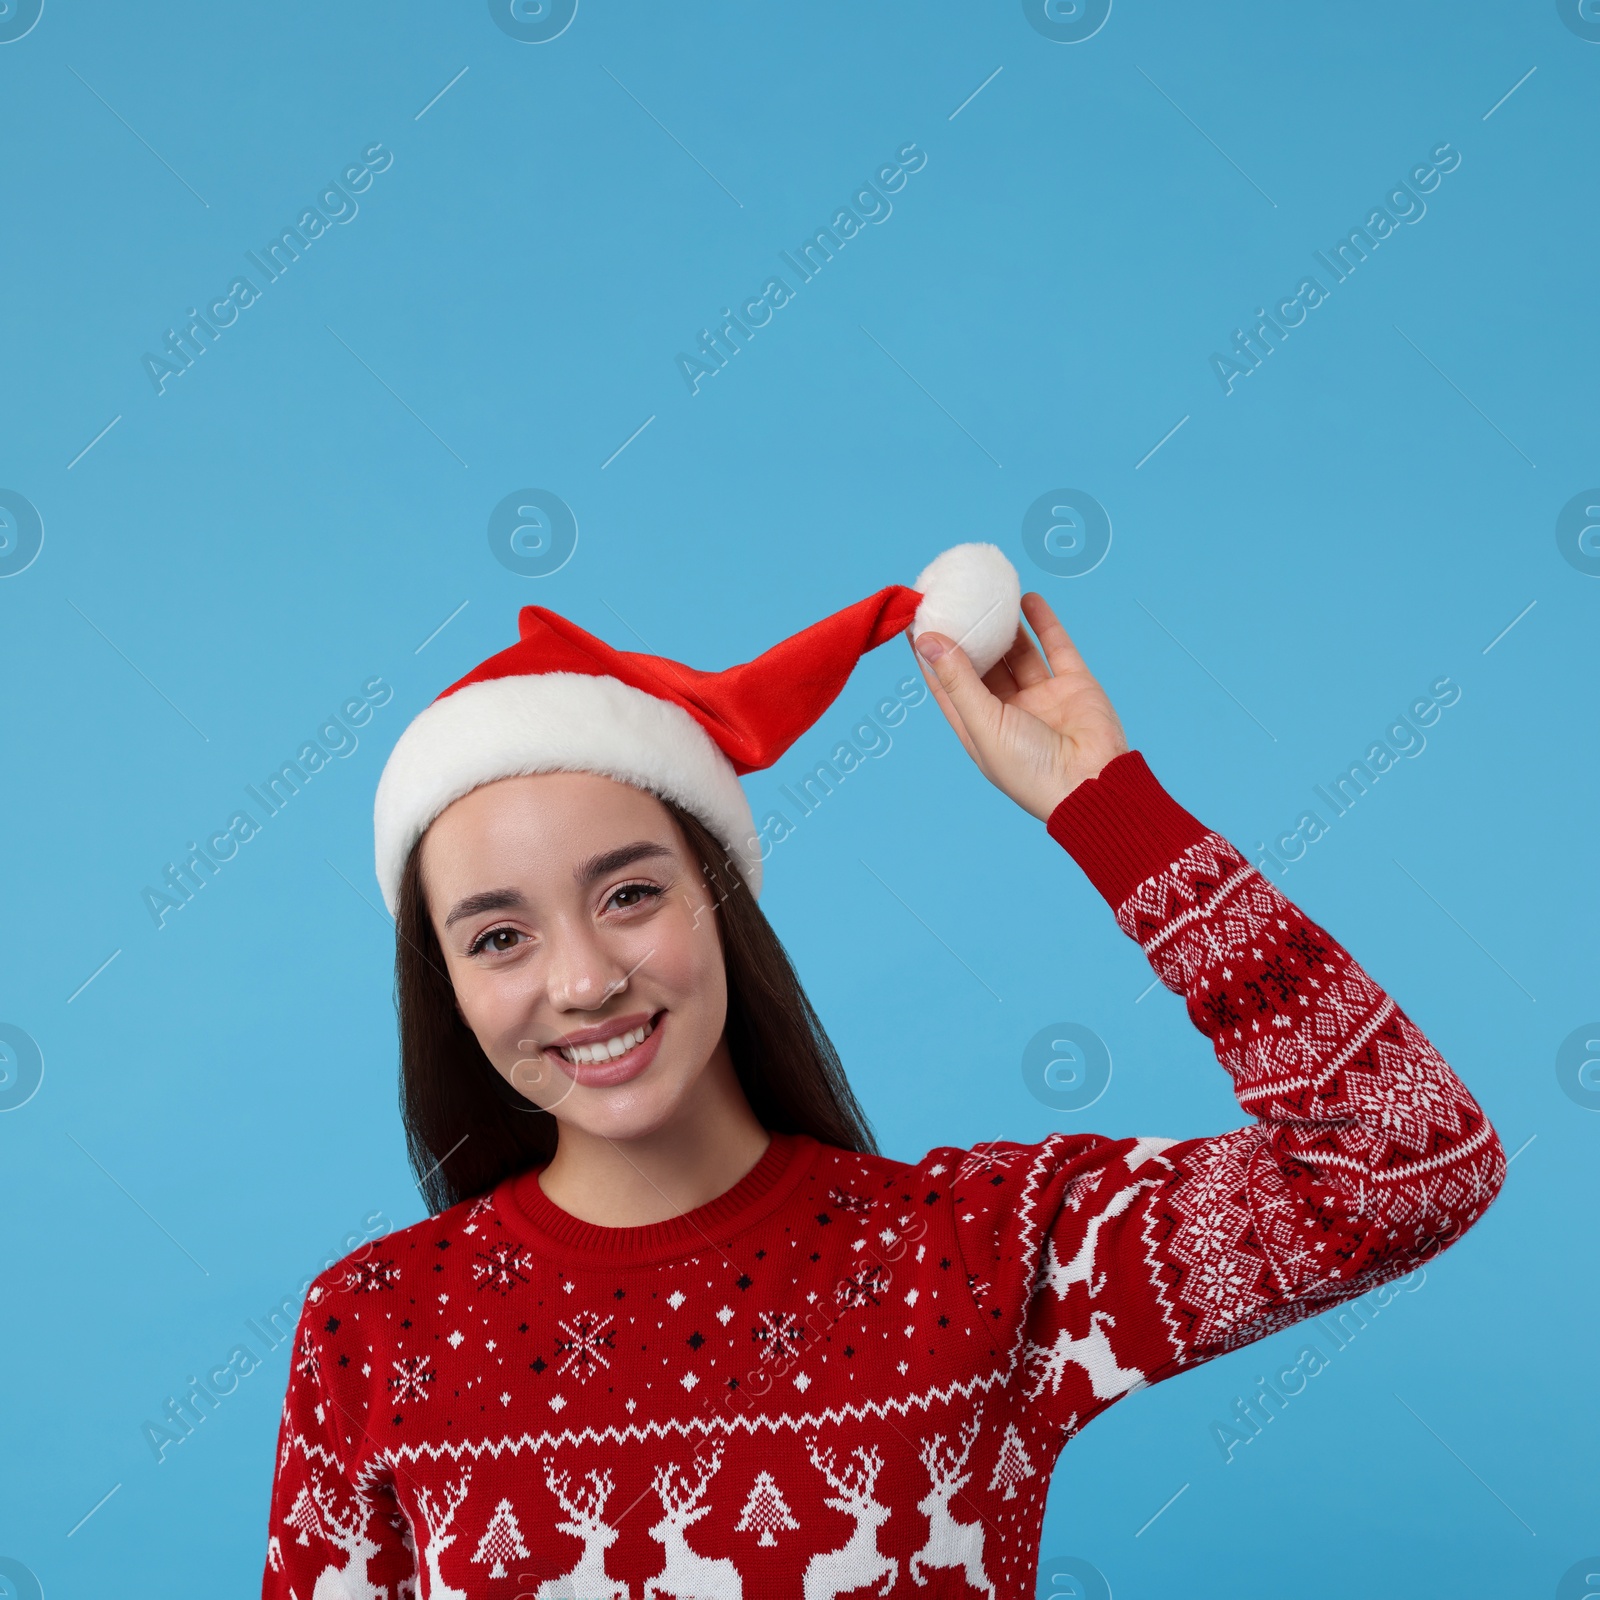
[0,0,1600,1597]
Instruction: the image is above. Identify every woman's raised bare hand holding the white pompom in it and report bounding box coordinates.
[906,592,1128,822]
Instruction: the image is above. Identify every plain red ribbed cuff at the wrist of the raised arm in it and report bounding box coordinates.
[1045,750,1210,910]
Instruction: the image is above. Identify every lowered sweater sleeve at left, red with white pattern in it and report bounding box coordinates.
[261,1262,416,1600]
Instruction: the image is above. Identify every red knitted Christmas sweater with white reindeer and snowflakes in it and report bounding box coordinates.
[262,752,1506,1600]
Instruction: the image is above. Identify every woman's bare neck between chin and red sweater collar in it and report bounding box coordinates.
[538,1043,771,1227]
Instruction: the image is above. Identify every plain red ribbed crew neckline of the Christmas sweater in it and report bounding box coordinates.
[494,1133,821,1267]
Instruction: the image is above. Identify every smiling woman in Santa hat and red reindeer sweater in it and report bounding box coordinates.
[262,546,1504,1600]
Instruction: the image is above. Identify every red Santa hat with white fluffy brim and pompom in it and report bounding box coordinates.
[373,544,1022,912]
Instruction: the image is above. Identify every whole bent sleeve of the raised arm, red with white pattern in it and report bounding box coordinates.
[952,750,1506,1434]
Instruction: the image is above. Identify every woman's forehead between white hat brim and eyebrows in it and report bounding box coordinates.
[422,773,682,893]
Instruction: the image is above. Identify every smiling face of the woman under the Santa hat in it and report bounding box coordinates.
[421,773,728,1139]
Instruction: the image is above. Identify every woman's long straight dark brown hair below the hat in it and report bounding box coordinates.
[395,787,878,1213]
